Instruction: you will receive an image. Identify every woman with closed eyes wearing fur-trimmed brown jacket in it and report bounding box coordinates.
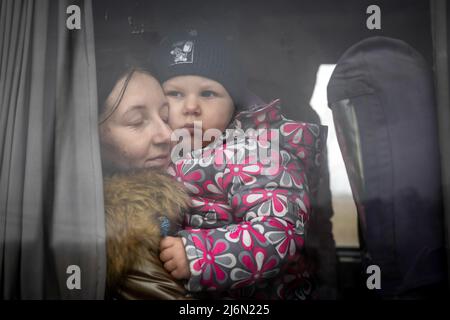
[99,69,189,299]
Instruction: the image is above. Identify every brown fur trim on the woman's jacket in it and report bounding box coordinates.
[104,170,189,292]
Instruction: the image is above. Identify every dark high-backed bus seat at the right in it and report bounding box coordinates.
[328,37,446,296]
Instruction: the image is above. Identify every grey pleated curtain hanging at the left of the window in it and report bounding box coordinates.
[0,0,106,299]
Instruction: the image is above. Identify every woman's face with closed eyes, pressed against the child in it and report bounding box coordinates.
[100,71,172,171]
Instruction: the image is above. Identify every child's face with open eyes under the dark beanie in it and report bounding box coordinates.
[163,76,234,146]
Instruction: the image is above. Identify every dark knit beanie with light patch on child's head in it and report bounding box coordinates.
[153,29,245,108]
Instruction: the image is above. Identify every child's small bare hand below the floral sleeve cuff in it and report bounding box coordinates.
[159,237,191,280]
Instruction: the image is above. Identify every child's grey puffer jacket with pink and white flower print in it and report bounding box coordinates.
[169,100,327,299]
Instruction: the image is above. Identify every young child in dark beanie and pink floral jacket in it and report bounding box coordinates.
[157,31,327,299]
